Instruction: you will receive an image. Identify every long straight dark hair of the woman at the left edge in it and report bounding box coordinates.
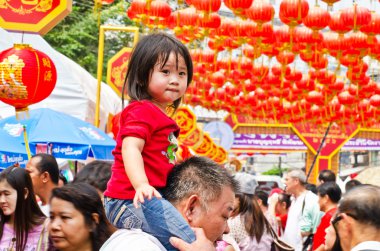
[0,166,46,251]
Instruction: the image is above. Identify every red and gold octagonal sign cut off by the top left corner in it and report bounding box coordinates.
[0,0,72,35]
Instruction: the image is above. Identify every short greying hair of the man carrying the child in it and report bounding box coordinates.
[163,156,239,208]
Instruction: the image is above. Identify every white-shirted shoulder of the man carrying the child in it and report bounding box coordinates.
[100,229,166,251]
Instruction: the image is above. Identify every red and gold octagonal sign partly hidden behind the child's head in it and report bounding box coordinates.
[107,48,132,97]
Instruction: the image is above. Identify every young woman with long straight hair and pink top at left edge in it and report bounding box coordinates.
[0,166,51,251]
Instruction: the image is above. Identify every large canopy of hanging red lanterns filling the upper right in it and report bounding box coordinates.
[127,0,380,127]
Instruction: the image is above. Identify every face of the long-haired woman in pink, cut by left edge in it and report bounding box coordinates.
[0,180,17,216]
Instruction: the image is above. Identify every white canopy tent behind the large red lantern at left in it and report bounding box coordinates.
[0,28,121,128]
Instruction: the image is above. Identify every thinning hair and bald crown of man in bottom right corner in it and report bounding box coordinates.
[338,185,380,229]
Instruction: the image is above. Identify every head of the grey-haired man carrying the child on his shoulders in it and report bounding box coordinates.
[163,156,239,241]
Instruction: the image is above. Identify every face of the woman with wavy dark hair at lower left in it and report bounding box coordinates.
[49,198,92,251]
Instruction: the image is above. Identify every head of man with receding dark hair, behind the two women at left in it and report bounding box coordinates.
[26,153,59,196]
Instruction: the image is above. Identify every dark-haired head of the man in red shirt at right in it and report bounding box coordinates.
[317,181,342,212]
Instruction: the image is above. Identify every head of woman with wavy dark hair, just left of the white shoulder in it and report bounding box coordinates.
[49,183,116,251]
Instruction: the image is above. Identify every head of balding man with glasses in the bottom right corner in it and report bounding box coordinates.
[332,185,380,249]
